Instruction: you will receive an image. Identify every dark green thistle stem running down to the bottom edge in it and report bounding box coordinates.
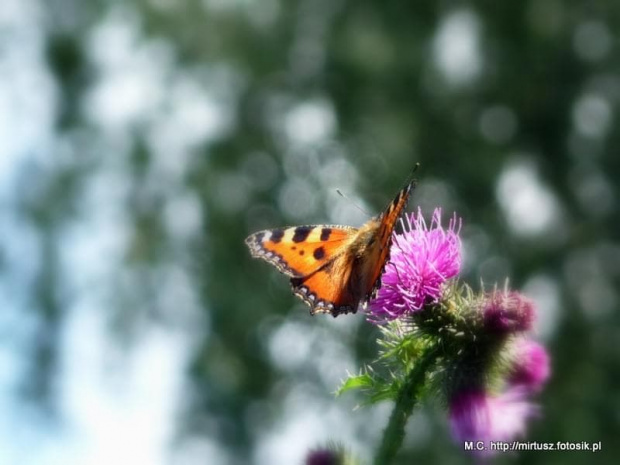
[374,347,438,465]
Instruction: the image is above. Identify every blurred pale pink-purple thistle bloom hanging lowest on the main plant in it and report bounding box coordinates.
[450,386,538,455]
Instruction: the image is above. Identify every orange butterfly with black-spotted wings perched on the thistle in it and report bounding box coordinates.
[245,180,416,316]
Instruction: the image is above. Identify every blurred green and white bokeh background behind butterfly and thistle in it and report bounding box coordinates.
[0,0,620,465]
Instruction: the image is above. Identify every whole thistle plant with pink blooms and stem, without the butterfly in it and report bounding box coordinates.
[339,205,550,464]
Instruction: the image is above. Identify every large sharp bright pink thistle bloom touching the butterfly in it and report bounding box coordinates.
[370,208,461,322]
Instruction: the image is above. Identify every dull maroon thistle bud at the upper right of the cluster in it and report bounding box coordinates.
[482,291,536,334]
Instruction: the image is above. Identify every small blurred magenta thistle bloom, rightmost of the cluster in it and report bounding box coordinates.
[509,339,551,392]
